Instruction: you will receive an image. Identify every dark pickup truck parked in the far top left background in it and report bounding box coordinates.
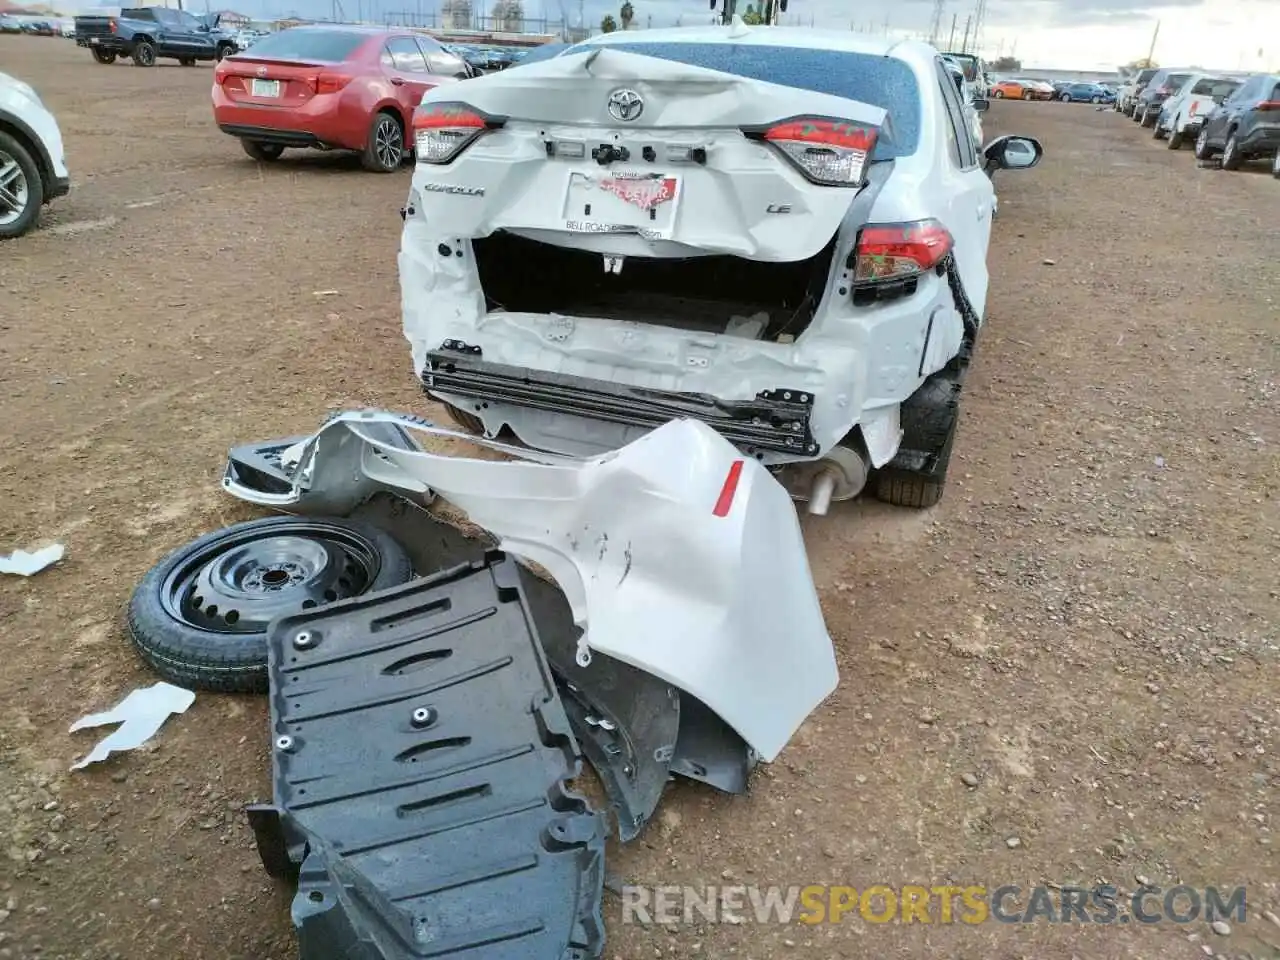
[76,6,237,67]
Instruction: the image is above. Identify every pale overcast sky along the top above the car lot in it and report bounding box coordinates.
[204,0,1280,69]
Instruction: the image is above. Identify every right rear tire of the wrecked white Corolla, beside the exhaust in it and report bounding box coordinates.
[874,370,961,509]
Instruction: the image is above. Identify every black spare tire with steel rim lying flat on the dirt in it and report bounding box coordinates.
[128,517,413,692]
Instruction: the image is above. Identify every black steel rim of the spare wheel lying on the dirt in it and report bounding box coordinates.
[160,522,381,635]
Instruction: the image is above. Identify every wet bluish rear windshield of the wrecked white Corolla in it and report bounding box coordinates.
[581,44,920,160]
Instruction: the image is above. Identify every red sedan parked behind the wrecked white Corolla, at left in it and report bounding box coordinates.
[214,24,468,173]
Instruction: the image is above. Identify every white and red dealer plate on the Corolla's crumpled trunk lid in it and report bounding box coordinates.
[563,170,681,239]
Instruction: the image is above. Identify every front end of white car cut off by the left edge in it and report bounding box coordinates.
[0,73,70,241]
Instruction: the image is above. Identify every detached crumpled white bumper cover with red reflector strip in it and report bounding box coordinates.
[223,411,837,760]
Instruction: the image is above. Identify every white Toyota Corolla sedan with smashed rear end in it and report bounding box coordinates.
[399,20,1042,513]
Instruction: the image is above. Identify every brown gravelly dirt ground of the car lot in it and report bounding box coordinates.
[0,37,1280,960]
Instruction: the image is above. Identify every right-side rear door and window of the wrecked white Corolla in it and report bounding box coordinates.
[936,58,996,316]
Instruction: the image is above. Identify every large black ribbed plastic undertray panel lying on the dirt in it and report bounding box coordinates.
[256,552,607,960]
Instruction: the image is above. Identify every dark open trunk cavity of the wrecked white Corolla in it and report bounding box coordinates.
[474,230,835,340]
